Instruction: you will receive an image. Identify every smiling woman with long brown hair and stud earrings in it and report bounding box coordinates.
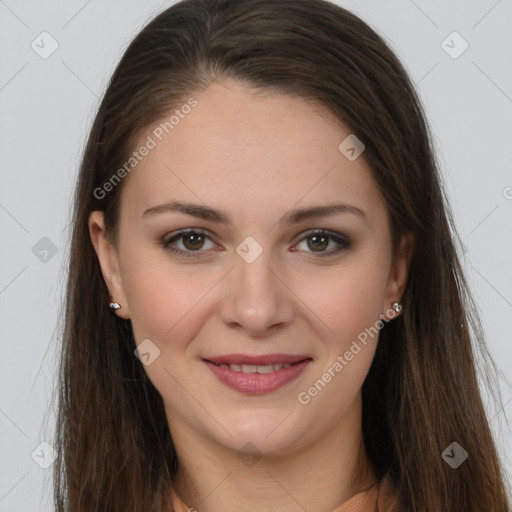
[55,0,510,512]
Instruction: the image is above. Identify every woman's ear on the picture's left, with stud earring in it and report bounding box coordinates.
[89,210,130,319]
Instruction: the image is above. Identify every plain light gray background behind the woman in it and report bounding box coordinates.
[0,0,512,512]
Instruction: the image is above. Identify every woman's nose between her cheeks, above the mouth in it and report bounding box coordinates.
[220,246,295,337]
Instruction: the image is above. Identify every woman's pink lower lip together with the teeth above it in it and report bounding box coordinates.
[205,359,311,395]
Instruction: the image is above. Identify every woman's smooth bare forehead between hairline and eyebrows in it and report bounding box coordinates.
[118,81,385,228]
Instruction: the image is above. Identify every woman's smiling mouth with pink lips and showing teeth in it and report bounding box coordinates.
[203,354,313,395]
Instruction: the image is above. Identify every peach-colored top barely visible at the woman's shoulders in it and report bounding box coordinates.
[164,479,398,512]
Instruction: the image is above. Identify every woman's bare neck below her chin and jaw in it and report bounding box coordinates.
[171,398,376,512]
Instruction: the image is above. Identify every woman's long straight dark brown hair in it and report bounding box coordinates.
[54,0,509,512]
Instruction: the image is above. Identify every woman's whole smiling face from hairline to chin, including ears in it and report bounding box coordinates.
[89,82,408,454]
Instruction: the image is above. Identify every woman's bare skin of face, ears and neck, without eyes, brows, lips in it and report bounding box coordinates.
[89,81,412,512]
